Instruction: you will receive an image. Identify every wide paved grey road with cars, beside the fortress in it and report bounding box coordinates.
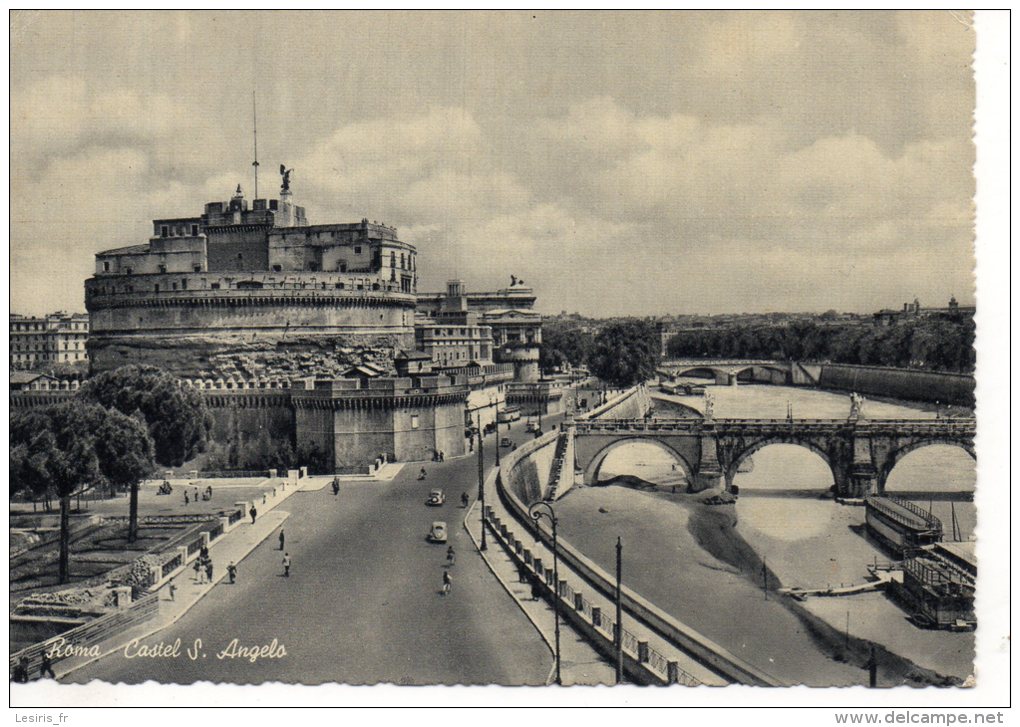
[67,424,552,684]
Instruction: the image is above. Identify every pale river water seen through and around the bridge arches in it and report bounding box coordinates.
[591,384,977,679]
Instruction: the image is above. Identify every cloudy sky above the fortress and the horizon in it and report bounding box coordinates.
[10,11,974,315]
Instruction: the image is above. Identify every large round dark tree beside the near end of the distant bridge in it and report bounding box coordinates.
[589,320,659,386]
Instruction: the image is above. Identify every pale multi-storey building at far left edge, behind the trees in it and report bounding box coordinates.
[9,312,89,369]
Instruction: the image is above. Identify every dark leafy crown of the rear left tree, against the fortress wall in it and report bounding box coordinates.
[79,365,212,467]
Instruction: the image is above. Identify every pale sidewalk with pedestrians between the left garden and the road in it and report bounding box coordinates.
[54,478,306,680]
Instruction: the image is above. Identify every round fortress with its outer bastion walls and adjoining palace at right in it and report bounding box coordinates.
[85,167,562,468]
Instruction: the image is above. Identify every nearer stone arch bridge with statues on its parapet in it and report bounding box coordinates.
[566,418,976,498]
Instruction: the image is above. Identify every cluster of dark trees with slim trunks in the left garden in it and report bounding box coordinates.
[9,366,212,583]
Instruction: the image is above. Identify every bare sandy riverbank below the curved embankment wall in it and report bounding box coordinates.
[558,485,972,686]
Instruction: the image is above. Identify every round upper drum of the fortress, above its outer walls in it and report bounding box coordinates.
[86,181,417,376]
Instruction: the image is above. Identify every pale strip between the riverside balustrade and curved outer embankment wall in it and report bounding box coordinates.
[474,485,730,686]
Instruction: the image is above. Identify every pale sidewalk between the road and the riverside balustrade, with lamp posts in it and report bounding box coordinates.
[464,502,616,686]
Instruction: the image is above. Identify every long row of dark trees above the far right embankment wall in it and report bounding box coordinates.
[667,317,975,372]
